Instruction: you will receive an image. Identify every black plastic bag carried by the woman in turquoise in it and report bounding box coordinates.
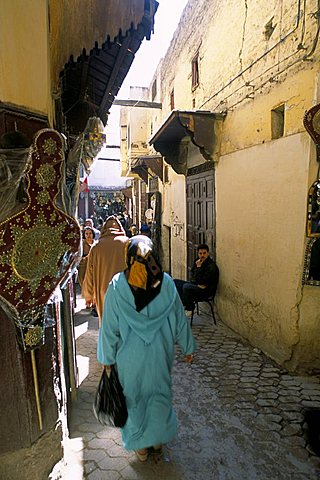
[93,365,128,428]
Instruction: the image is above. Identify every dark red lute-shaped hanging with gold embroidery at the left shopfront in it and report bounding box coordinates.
[0,129,80,348]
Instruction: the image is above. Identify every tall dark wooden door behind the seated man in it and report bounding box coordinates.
[187,166,216,274]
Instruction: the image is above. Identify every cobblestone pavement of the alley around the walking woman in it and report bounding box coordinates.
[55,302,320,480]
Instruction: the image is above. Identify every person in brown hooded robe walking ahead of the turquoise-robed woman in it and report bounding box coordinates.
[82,215,129,324]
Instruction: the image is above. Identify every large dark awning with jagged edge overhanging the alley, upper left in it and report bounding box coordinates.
[55,0,158,135]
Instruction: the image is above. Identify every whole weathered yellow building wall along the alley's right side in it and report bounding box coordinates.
[150,0,320,371]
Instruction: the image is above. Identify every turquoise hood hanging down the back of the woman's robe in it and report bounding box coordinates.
[109,272,177,344]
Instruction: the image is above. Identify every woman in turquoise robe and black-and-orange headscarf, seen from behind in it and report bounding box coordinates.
[97,235,195,461]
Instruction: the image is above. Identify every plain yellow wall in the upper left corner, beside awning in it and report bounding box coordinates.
[0,0,50,114]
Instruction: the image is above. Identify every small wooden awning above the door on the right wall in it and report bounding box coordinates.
[149,110,225,174]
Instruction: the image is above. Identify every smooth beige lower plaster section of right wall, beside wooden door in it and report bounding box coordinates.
[216,133,320,367]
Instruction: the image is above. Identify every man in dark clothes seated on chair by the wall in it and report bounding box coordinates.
[174,243,219,316]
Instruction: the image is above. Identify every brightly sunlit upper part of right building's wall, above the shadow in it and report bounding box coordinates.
[160,0,319,123]
